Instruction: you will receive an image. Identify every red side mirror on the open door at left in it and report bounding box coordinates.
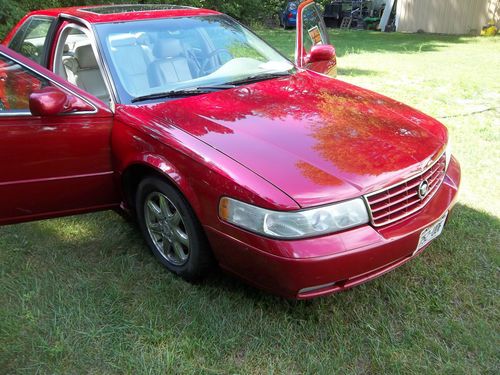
[29,87,94,116]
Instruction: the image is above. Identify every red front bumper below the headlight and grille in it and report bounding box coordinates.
[205,158,460,299]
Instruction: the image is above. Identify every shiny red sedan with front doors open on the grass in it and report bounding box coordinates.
[0,1,460,299]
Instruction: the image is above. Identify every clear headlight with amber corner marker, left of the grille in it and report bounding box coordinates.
[219,197,369,239]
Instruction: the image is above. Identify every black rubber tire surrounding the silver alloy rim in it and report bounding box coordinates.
[136,177,213,282]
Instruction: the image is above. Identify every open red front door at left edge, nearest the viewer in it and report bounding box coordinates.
[0,46,119,224]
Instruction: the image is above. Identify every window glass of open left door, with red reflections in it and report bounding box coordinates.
[0,55,50,115]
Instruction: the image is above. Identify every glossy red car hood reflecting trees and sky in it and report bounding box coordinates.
[129,72,447,207]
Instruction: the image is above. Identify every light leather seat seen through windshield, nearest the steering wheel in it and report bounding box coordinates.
[148,38,193,87]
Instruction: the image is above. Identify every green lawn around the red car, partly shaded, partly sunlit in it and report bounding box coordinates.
[0,31,500,374]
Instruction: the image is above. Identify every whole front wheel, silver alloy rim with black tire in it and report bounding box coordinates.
[136,177,212,281]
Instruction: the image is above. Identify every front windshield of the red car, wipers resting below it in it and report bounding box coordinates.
[96,15,294,103]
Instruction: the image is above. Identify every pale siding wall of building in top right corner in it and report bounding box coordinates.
[397,0,500,34]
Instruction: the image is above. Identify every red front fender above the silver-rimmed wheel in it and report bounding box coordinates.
[111,107,300,227]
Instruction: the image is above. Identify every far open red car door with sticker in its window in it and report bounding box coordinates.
[295,0,337,77]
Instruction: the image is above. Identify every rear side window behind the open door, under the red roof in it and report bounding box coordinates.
[9,17,54,64]
